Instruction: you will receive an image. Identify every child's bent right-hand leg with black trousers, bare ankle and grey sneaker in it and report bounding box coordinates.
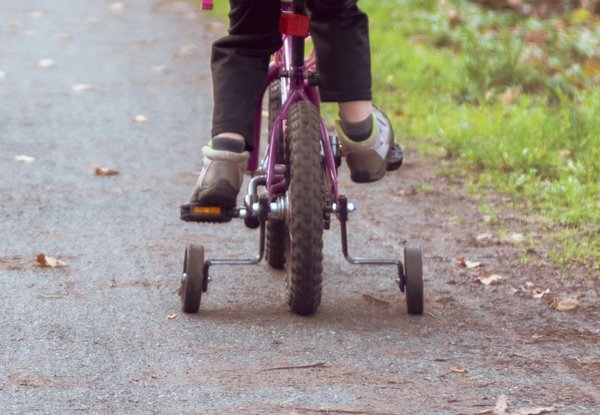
[308,0,394,182]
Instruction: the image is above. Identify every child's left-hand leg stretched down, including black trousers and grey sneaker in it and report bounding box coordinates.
[191,0,281,208]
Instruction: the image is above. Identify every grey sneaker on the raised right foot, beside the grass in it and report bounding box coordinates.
[336,107,401,183]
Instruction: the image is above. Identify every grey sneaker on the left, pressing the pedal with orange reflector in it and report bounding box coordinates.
[190,144,250,209]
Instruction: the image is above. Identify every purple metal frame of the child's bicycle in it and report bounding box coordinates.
[248,19,338,203]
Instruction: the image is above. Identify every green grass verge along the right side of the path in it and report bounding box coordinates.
[197,0,600,270]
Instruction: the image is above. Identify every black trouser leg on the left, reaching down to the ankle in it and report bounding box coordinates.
[211,0,281,150]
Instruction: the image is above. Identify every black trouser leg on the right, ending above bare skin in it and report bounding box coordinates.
[308,0,372,102]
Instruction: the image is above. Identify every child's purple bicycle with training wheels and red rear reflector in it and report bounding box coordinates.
[180,0,423,315]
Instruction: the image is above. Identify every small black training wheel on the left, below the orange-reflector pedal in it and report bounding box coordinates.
[181,244,204,314]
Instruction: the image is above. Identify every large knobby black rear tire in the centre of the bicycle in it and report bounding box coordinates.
[285,101,325,315]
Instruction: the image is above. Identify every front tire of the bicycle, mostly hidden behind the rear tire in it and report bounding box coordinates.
[265,79,288,269]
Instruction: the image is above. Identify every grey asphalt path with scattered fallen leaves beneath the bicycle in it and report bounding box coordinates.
[0,0,600,415]
